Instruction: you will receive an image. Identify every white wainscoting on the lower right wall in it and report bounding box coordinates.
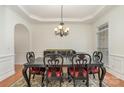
[109,54,124,80]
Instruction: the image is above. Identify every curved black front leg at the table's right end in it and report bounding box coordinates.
[98,66,106,87]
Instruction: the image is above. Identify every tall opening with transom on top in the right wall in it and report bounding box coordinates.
[97,23,109,67]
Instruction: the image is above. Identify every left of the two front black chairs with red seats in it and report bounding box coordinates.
[43,54,63,86]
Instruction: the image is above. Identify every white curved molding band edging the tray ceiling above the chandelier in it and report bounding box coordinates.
[17,5,113,22]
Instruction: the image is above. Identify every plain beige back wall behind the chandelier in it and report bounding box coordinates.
[32,23,95,54]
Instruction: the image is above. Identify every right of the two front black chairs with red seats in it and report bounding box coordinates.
[68,53,91,86]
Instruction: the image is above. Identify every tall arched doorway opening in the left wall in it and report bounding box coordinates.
[14,24,29,64]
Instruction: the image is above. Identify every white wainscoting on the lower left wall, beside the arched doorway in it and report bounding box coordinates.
[0,55,15,81]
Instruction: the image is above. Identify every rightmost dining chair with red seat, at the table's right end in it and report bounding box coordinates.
[89,51,103,78]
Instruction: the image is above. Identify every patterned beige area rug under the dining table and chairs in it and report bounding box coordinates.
[10,75,109,87]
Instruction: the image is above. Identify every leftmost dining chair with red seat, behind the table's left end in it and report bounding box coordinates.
[26,51,45,83]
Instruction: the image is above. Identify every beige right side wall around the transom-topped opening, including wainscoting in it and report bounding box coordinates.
[94,6,124,80]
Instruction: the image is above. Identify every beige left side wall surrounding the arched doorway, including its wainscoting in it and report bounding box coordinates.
[0,6,31,81]
